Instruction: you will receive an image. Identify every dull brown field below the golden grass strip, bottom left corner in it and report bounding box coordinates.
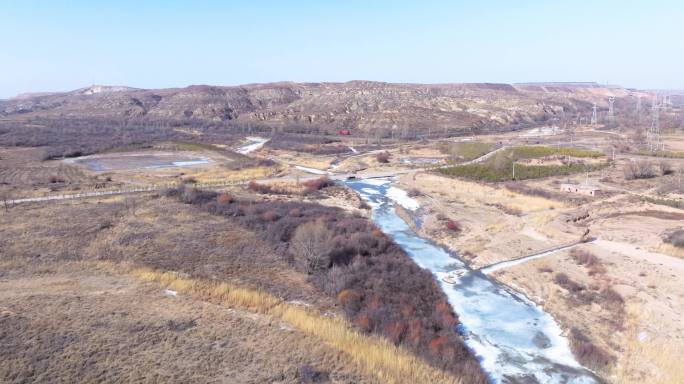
[0,262,380,383]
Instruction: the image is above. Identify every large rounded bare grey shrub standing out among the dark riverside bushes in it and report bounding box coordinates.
[290,220,334,273]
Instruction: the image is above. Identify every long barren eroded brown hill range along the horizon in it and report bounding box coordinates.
[0,81,630,131]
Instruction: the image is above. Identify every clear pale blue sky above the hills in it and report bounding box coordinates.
[0,0,684,98]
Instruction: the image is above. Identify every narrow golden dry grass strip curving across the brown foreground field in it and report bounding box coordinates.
[129,268,462,384]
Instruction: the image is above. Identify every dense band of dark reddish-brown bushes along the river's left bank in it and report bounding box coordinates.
[166,186,486,383]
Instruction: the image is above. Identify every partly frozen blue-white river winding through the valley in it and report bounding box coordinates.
[347,179,599,384]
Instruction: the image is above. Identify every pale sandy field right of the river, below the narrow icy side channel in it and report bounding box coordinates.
[497,242,684,383]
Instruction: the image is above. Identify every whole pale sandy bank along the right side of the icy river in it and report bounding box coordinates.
[390,174,684,383]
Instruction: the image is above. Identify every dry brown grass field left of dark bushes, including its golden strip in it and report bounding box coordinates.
[0,192,477,383]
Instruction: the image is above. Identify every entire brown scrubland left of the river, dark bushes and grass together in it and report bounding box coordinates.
[0,190,484,383]
